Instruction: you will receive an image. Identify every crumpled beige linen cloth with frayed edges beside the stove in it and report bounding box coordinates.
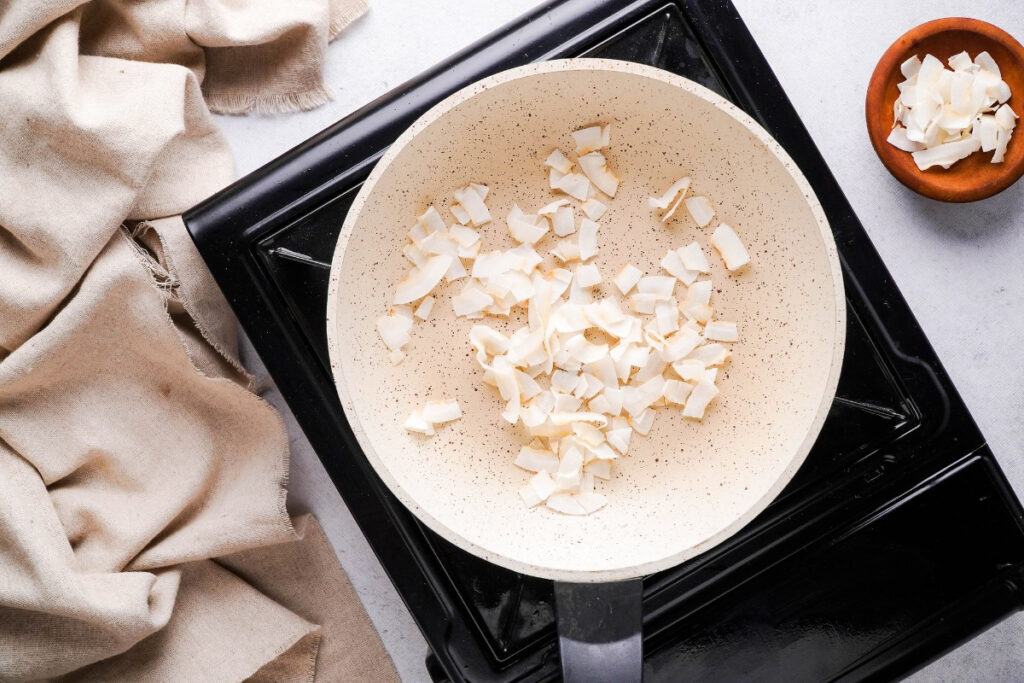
[0,0,395,681]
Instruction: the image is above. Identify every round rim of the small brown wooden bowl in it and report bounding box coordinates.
[864,16,1024,203]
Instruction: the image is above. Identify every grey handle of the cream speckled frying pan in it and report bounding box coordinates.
[555,579,643,683]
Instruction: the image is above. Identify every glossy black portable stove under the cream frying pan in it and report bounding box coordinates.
[185,0,1024,681]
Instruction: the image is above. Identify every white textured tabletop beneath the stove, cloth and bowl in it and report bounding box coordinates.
[221,0,1024,683]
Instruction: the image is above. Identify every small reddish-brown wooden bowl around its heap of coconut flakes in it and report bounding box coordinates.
[864,16,1024,202]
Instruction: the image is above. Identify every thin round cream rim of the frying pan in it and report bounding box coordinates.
[327,58,846,583]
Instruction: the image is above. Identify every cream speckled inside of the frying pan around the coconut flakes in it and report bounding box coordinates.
[327,59,845,582]
